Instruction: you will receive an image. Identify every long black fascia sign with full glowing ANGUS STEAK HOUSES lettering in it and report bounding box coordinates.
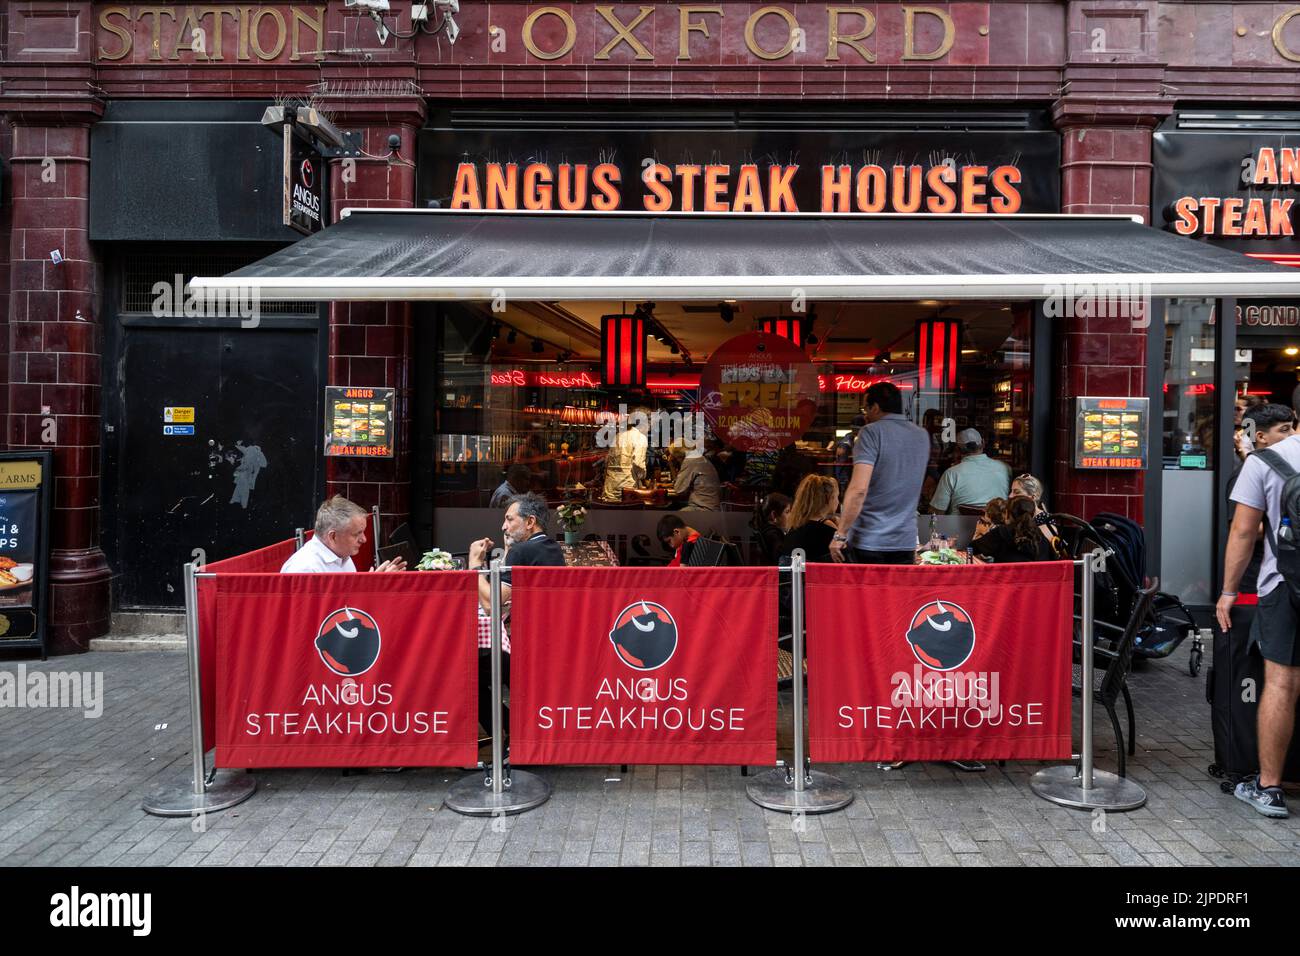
[416,129,1061,215]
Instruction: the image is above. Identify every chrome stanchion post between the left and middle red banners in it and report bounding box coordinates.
[443,555,551,817]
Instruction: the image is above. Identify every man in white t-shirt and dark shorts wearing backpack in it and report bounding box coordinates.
[1216,436,1300,817]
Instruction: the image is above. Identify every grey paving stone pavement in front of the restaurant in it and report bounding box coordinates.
[0,645,1300,866]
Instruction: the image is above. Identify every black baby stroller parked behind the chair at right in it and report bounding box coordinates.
[1053,511,1205,678]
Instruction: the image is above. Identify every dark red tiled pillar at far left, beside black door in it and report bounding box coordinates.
[0,95,112,653]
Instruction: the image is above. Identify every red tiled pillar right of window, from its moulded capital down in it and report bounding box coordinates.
[1048,83,1171,522]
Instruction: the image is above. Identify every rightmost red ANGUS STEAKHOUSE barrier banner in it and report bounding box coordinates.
[806,562,1074,762]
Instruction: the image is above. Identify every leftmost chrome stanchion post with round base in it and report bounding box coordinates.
[140,564,257,817]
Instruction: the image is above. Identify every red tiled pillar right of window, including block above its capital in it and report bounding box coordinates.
[1045,20,1173,522]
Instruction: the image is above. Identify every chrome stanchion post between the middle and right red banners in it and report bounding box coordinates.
[745,548,853,813]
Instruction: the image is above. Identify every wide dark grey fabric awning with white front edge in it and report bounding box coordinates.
[185,209,1300,302]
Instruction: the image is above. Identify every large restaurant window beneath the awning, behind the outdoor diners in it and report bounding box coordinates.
[433,302,1034,563]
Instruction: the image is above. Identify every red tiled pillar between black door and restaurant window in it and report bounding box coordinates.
[324,98,425,548]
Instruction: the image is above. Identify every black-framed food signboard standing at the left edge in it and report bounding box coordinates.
[0,450,55,661]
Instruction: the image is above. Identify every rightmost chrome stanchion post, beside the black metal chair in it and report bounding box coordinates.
[1030,548,1147,812]
